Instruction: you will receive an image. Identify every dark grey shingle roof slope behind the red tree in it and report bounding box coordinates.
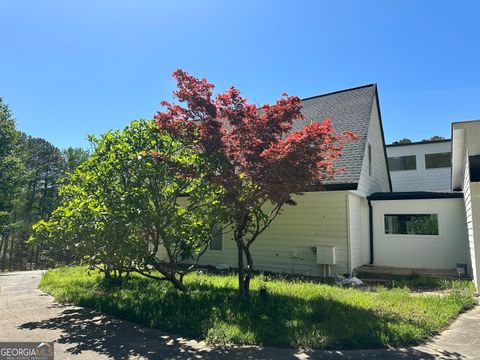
[293,84,376,184]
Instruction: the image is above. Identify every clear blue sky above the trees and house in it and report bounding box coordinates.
[0,0,480,147]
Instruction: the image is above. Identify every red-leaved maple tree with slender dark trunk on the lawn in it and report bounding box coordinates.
[155,69,356,296]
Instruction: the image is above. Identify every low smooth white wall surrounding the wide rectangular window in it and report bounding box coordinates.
[372,198,469,269]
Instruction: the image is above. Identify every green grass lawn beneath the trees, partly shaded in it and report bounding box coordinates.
[40,267,476,349]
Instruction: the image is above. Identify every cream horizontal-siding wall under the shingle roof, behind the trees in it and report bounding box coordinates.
[159,191,349,276]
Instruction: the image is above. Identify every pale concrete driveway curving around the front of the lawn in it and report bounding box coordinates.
[0,271,480,360]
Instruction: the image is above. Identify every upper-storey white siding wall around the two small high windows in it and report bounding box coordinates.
[387,141,451,191]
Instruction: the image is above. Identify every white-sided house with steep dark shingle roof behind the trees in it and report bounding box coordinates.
[160,84,480,285]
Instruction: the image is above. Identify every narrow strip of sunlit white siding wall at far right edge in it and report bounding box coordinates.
[463,154,480,289]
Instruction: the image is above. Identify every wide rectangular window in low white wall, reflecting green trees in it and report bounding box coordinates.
[385,214,438,235]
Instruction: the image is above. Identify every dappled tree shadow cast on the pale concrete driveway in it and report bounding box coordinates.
[20,308,465,360]
